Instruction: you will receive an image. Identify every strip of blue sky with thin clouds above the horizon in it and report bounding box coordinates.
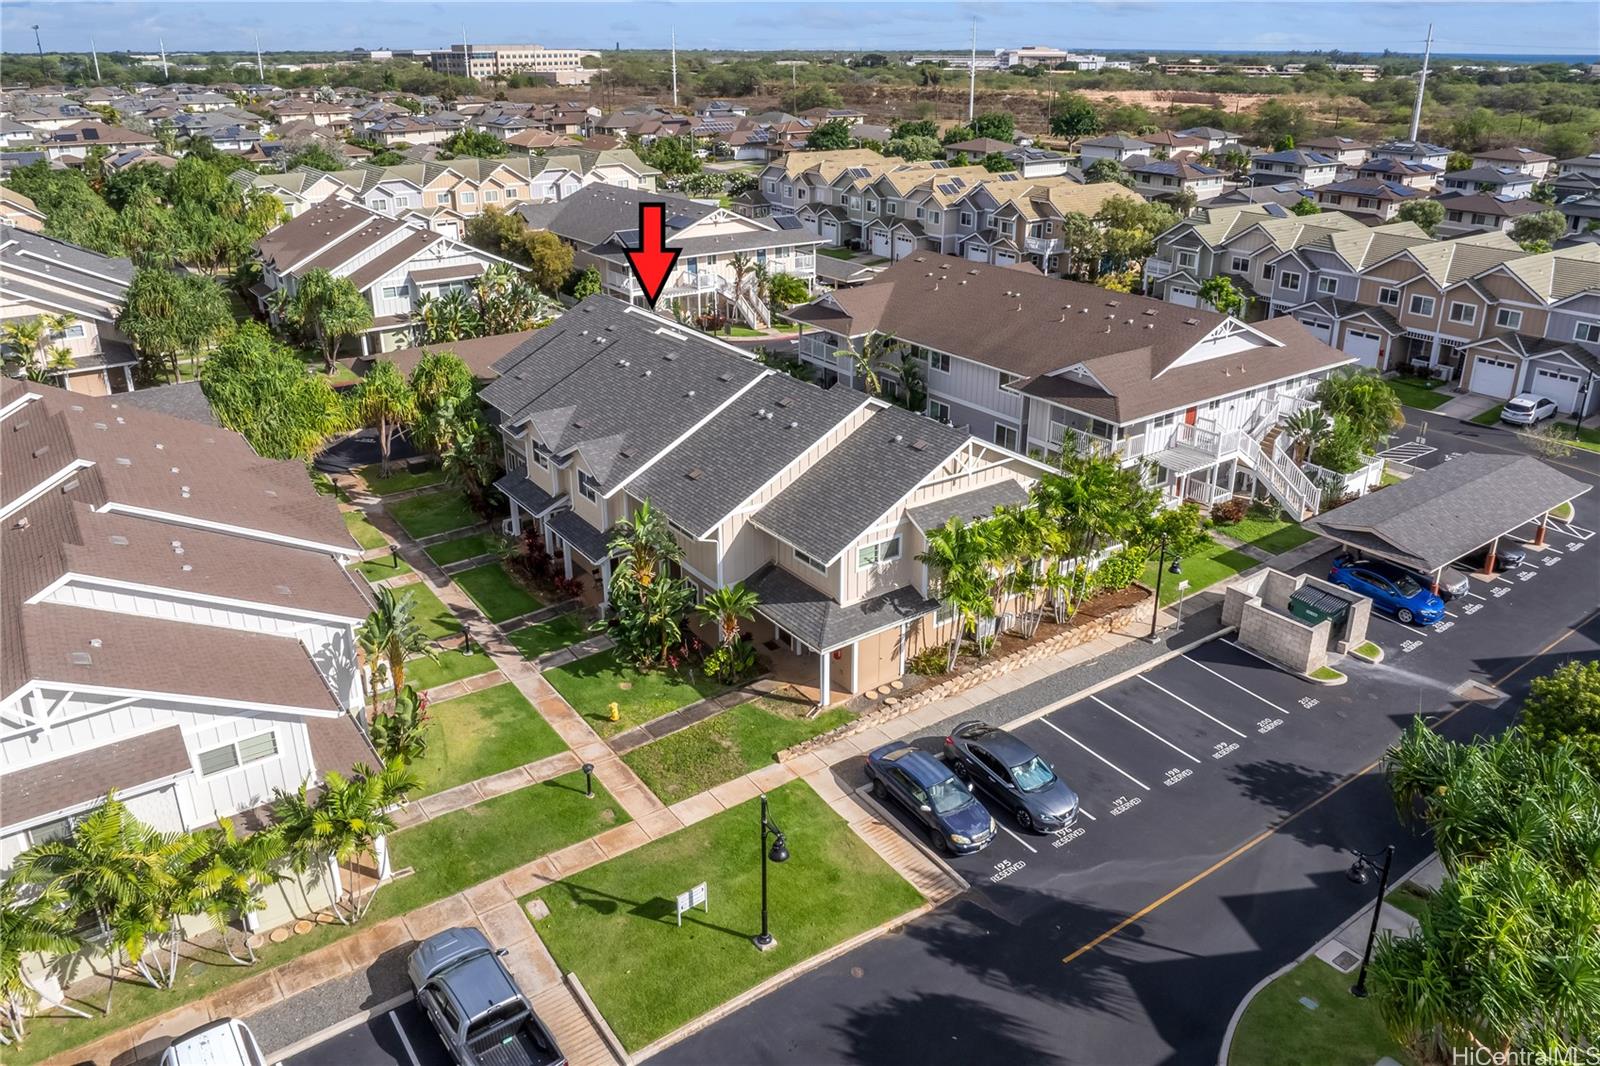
[0,0,1600,59]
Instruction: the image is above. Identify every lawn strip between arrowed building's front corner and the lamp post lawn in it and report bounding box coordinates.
[622,701,851,804]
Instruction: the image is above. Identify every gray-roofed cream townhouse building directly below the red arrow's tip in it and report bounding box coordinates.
[482,296,1043,707]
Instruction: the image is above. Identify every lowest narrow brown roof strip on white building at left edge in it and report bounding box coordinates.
[0,725,190,828]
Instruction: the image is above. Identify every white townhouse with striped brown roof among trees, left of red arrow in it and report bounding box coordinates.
[250,200,514,355]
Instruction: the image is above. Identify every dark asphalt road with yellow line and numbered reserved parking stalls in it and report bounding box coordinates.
[658,427,1600,1066]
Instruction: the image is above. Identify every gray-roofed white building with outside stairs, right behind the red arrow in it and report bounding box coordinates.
[518,186,822,327]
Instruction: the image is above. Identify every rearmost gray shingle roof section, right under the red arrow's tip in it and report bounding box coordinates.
[482,296,766,493]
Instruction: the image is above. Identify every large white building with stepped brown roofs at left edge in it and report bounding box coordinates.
[0,379,378,869]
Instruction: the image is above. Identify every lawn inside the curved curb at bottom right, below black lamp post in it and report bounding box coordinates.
[1227,957,1413,1066]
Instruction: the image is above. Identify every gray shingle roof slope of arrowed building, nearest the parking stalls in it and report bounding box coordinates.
[754,407,970,562]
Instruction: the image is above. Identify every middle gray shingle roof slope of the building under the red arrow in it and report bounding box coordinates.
[630,375,867,536]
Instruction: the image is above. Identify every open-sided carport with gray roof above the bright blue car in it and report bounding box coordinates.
[1304,451,1590,594]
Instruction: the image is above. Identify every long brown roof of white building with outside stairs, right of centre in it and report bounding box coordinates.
[786,253,1350,423]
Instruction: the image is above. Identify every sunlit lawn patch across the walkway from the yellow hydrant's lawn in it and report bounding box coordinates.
[411,683,566,795]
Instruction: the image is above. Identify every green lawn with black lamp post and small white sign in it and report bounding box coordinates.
[534,781,922,1052]
